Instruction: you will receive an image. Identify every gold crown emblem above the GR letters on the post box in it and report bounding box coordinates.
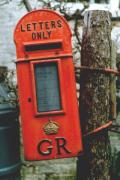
[43,119,59,135]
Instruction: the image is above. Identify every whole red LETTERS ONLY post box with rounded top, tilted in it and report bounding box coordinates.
[14,10,82,160]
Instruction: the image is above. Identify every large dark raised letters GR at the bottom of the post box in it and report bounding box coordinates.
[37,137,71,156]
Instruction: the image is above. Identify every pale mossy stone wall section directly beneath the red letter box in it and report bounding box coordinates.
[21,158,76,180]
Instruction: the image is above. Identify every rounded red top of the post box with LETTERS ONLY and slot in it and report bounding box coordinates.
[14,9,72,61]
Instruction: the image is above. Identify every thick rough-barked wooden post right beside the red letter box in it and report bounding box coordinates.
[77,10,111,180]
